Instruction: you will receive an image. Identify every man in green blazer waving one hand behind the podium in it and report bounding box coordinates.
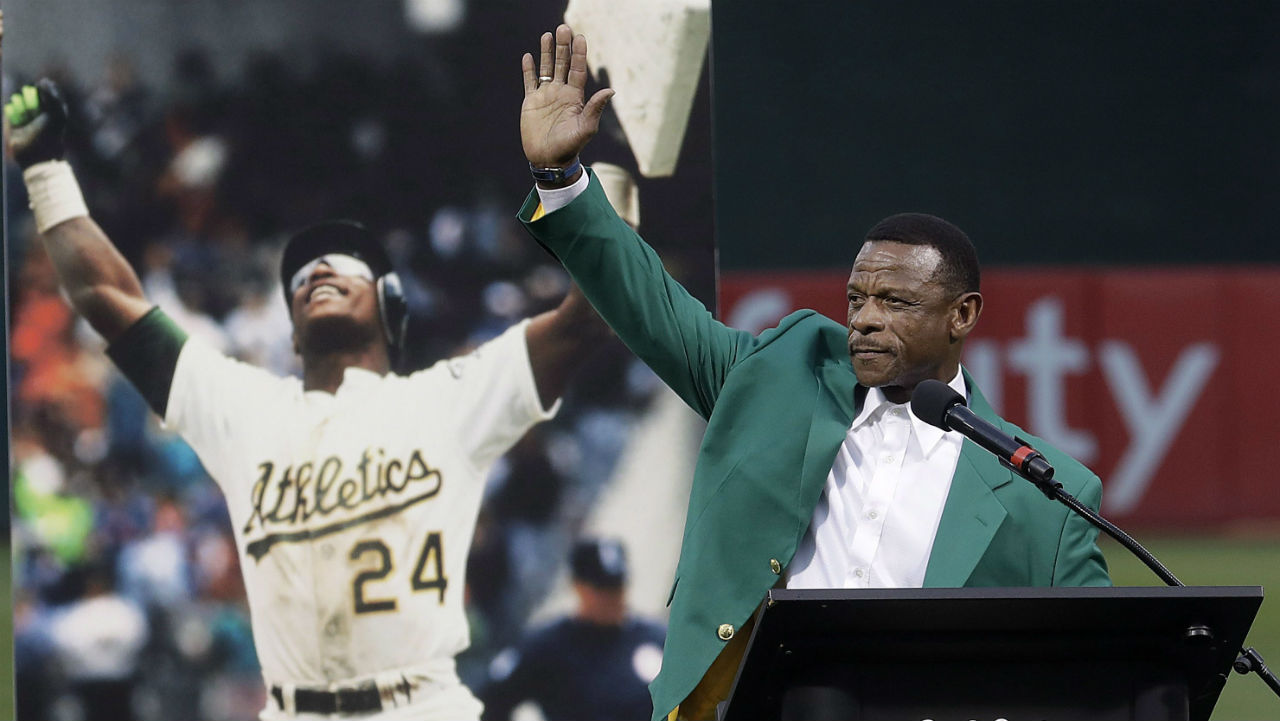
[509,26,1111,721]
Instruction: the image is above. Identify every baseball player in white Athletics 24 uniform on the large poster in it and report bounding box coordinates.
[5,81,607,721]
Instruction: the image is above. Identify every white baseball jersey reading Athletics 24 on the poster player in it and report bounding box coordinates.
[165,321,558,717]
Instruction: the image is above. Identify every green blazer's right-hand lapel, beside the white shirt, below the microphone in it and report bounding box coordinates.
[924,373,1014,588]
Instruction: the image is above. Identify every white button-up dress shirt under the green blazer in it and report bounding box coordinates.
[787,370,968,588]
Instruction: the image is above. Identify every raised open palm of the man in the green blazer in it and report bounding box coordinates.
[520,24,613,168]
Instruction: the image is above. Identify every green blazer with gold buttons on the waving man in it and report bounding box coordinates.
[520,171,1111,721]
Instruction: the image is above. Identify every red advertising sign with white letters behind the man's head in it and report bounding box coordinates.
[719,268,1280,525]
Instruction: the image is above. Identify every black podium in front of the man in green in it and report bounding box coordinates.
[721,587,1262,721]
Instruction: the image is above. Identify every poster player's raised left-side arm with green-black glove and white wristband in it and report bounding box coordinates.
[5,79,151,342]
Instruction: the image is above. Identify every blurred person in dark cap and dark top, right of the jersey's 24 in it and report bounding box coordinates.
[480,539,666,721]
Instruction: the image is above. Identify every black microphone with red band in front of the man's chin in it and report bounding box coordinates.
[911,379,1053,485]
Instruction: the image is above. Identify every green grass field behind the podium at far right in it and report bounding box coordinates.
[1102,535,1280,721]
